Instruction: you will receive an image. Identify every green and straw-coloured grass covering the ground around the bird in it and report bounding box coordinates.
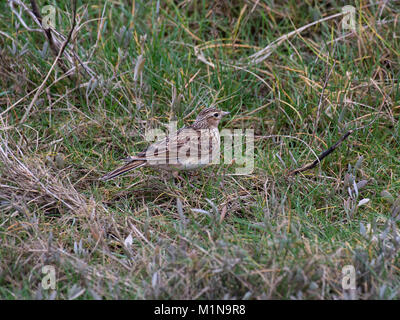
[0,0,400,299]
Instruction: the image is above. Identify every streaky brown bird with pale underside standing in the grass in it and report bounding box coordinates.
[100,107,230,181]
